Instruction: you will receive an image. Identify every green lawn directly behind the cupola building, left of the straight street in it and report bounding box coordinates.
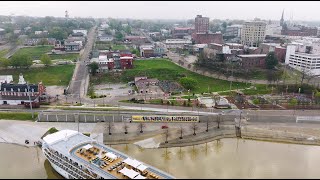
[0,65,75,86]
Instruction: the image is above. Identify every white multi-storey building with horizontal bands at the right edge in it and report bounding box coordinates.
[285,43,320,75]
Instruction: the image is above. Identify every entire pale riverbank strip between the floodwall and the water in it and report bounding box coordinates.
[0,120,320,148]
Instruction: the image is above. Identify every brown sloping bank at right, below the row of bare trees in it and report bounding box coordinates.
[159,124,320,148]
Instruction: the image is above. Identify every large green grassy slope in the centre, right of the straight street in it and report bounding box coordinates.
[91,59,250,93]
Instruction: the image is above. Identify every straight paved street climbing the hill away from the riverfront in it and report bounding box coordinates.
[68,26,97,98]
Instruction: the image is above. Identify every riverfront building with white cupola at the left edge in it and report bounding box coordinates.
[0,74,46,107]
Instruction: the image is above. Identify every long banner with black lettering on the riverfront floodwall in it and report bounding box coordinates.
[132,115,199,122]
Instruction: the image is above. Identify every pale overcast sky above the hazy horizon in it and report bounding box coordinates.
[0,1,320,21]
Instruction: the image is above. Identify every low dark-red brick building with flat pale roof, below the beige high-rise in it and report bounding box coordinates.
[236,54,267,68]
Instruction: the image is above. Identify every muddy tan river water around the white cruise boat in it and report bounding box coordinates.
[0,139,320,179]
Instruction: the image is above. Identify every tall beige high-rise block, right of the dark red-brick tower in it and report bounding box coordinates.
[241,21,266,47]
